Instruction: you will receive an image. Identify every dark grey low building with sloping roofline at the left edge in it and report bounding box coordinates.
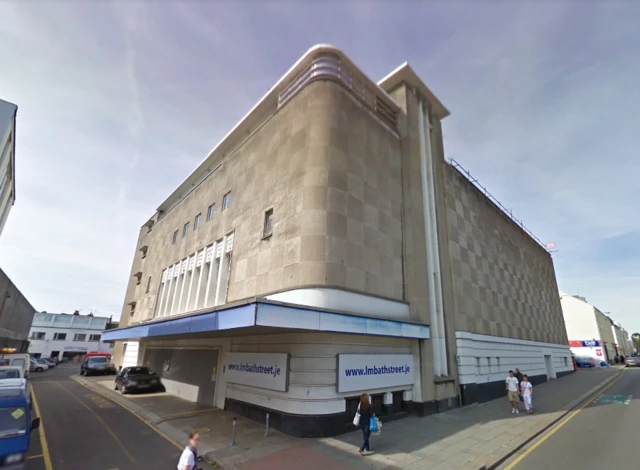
[0,269,35,352]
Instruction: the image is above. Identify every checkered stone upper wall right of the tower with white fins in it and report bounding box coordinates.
[445,163,567,344]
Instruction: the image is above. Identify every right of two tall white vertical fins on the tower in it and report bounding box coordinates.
[424,103,449,375]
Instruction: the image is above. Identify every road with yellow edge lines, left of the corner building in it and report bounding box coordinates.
[27,365,190,470]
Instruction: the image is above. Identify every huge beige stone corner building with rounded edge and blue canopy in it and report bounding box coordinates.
[105,46,570,436]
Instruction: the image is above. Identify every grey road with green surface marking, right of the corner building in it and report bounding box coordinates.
[500,368,640,470]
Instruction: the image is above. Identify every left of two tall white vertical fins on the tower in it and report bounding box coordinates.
[418,101,442,376]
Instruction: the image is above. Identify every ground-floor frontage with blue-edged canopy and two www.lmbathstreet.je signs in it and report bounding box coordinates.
[103,300,429,437]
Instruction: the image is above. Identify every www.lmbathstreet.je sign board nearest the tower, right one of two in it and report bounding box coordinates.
[337,354,414,392]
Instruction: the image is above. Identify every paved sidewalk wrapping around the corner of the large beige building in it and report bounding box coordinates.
[72,366,622,470]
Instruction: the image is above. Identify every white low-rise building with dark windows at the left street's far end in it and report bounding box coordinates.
[29,312,113,360]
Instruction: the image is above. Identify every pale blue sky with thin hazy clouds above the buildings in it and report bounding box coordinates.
[0,0,640,332]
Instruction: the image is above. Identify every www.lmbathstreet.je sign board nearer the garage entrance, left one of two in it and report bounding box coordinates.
[224,353,289,392]
